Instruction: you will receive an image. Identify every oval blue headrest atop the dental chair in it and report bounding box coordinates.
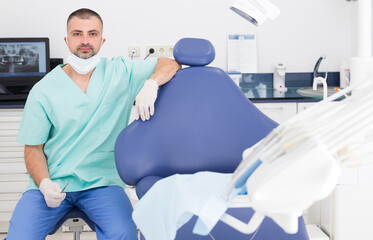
[174,38,215,66]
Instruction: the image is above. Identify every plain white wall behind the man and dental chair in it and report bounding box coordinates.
[0,0,357,72]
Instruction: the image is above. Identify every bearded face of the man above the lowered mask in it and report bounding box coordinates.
[65,16,105,59]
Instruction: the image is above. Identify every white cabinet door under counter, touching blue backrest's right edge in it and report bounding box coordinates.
[254,103,297,123]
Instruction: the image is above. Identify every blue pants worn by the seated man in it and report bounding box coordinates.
[6,186,137,240]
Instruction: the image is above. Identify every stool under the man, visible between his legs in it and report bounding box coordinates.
[49,207,95,240]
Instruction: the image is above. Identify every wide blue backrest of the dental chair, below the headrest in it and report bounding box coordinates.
[115,67,277,188]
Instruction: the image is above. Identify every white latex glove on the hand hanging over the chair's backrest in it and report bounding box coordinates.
[135,79,158,121]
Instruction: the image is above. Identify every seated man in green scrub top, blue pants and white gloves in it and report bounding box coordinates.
[7,9,180,240]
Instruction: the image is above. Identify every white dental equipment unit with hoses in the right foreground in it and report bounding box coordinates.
[222,82,373,233]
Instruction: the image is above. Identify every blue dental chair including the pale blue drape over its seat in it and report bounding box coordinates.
[115,38,308,240]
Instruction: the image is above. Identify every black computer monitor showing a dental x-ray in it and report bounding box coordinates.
[0,38,50,87]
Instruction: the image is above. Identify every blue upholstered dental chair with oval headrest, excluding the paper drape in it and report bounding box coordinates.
[115,38,308,240]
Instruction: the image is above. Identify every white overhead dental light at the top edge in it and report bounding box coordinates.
[230,0,280,26]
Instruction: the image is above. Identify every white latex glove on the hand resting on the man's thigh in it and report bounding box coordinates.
[39,178,66,208]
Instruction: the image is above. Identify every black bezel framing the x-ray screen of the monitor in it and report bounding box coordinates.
[0,37,50,86]
